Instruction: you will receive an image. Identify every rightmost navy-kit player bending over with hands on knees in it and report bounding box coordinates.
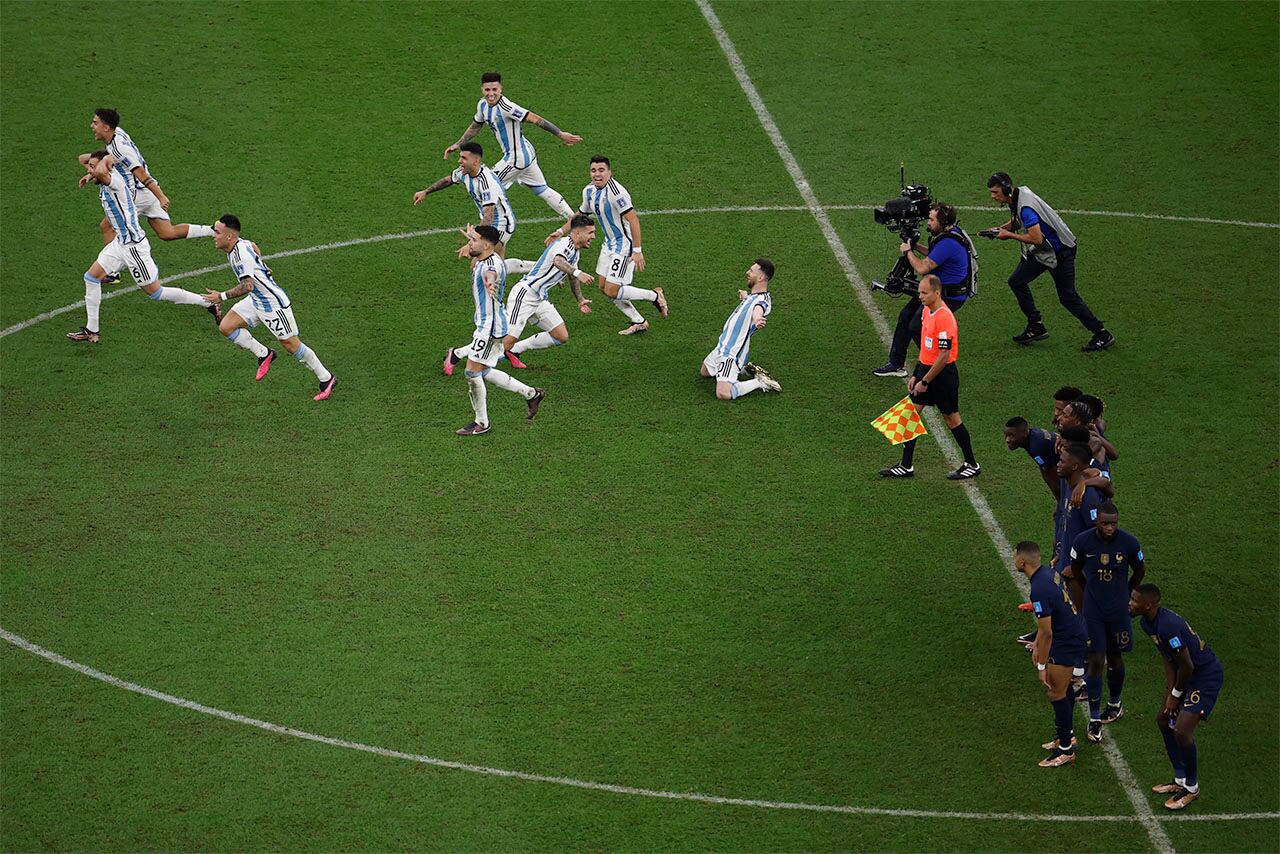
[1129,584,1222,809]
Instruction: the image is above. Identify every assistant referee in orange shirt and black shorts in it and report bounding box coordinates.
[881,274,982,480]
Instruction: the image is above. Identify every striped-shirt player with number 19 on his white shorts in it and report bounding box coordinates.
[447,225,547,435]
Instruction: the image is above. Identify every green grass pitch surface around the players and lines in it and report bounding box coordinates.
[0,1,1280,850]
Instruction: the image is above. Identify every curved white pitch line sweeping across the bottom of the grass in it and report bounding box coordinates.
[0,627,1280,822]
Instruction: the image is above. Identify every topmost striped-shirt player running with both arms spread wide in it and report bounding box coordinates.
[444,72,582,219]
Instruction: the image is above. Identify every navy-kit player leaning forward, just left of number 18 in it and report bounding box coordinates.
[1014,540,1088,768]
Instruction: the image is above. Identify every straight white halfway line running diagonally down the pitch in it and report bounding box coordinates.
[696,0,1174,853]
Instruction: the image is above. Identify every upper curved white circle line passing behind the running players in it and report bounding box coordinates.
[0,205,1280,338]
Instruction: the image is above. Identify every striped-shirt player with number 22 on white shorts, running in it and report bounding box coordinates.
[204,214,338,401]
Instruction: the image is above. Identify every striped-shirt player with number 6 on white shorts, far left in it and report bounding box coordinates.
[67,149,221,344]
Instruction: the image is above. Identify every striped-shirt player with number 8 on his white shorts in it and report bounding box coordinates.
[545,155,667,335]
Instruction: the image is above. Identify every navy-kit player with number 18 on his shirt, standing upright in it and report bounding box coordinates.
[1071,501,1147,741]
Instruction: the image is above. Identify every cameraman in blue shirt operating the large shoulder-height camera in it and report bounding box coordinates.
[872,202,978,376]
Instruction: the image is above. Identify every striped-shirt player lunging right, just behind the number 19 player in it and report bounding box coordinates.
[502,214,595,365]
